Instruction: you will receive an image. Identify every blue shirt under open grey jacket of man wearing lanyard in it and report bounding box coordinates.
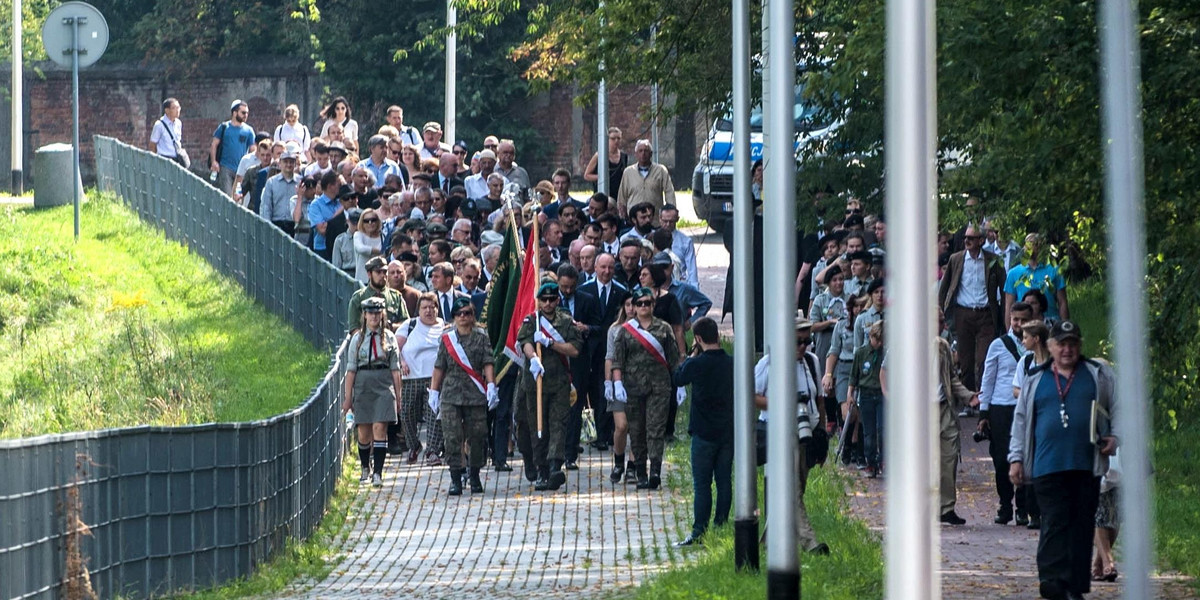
[1033,361,1096,478]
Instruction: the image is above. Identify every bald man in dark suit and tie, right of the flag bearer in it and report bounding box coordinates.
[578,254,629,450]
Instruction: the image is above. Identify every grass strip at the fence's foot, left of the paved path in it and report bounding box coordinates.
[172,460,367,600]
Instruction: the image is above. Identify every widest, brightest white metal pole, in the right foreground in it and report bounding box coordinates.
[884,0,940,600]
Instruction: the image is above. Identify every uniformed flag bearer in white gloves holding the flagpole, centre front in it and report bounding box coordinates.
[517,281,583,491]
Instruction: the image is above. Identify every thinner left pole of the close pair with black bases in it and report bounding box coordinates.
[726,0,758,571]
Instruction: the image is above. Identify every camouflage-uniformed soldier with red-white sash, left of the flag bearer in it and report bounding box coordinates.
[430,298,499,496]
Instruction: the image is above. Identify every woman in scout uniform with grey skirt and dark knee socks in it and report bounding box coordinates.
[342,298,402,487]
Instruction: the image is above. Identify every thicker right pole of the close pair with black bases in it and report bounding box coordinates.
[763,0,800,600]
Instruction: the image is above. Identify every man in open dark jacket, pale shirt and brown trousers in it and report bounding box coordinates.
[937,226,1006,390]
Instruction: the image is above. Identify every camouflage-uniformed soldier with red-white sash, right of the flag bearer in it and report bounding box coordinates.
[612,287,679,490]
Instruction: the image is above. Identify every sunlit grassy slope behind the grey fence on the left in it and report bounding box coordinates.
[0,193,329,438]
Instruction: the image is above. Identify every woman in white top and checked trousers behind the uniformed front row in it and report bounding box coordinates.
[396,292,445,464]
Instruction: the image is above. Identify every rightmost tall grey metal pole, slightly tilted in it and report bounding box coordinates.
[1091,0,1154,599]
